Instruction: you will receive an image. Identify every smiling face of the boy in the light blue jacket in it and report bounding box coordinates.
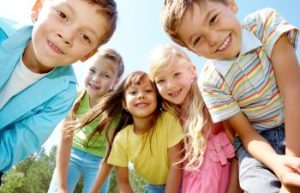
[23,0,108,72]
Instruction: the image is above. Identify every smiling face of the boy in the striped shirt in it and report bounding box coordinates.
[178,0,242,59]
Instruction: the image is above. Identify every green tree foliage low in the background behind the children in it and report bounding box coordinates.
[0,146,144,193]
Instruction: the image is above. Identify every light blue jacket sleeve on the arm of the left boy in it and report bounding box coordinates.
[0,88,76,172]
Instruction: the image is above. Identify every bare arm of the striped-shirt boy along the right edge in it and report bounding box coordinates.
[271,34,300,157]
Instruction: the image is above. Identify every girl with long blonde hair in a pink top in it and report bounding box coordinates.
[150,45,238,193]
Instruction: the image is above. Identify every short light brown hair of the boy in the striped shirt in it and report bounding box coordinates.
[161,0,226,47]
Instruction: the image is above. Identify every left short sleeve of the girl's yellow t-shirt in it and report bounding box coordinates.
[108,132,128,167]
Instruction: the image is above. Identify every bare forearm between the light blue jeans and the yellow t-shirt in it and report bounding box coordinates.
[90,160,112,193]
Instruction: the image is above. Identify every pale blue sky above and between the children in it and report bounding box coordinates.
[0,0,300,149]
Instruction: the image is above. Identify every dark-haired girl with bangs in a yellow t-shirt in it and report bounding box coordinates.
[82,71,183,193]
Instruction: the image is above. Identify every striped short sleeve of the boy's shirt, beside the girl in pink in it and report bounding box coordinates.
[198,68,241,123]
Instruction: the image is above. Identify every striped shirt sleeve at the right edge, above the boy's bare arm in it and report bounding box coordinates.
[243,8,299,57]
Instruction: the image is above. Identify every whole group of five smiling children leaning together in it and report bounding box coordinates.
[0,0,300,193]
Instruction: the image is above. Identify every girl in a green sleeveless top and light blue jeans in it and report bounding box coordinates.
[48,48,124,193]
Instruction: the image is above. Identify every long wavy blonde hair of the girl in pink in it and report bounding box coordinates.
[150,45,210,170]
